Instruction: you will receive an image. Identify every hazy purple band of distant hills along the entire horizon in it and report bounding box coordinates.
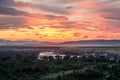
[0,40,120,46]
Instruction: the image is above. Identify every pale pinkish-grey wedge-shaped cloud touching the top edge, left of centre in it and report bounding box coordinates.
[17,0,72,15]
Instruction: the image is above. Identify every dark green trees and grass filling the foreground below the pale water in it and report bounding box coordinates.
[0,51,120,80]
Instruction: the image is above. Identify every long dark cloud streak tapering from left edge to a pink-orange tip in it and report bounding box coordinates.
[0,6,68,20]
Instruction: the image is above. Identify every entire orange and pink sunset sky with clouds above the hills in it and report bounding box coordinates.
[0,0,120,42]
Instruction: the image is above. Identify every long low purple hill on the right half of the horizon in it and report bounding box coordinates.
[61,40,120,46]
